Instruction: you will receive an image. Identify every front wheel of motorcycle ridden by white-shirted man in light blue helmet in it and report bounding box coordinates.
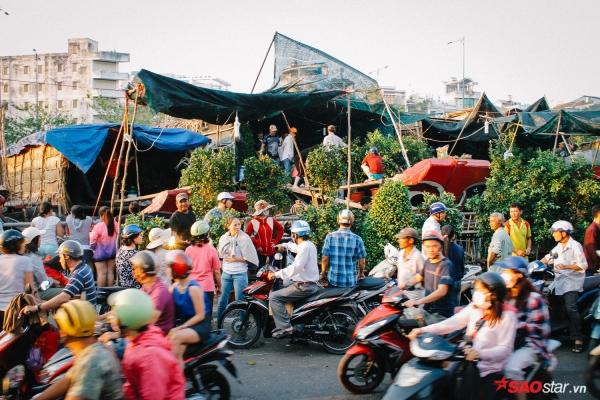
[219,306,262,349]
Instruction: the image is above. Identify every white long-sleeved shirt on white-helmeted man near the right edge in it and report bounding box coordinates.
[546,238,587,296]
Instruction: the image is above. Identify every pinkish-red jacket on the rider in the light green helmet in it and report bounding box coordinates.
[122,325,185,400]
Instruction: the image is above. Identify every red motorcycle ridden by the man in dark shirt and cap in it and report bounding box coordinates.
[337,287,419,394]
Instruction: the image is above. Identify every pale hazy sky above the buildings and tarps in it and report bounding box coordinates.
[0,0,600,105]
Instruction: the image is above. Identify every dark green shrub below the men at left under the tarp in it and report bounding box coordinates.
[243,156,291,211]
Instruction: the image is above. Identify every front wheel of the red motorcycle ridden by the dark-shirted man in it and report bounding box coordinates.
[337,354,385,394]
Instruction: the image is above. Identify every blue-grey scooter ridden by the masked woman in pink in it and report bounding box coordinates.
[383,333,560,400]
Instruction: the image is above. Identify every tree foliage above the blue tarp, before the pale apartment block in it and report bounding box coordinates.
[4,106,76,144]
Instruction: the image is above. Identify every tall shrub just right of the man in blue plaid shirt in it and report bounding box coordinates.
[361,181,415,269]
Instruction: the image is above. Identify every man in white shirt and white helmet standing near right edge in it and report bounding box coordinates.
[542,221,587,353]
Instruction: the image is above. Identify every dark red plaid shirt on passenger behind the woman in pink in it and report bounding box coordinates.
[513,292,550,358]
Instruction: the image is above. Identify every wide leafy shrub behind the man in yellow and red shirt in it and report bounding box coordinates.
[466,144,600,252]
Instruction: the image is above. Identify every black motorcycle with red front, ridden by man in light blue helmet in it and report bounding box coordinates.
[218,265,360,354]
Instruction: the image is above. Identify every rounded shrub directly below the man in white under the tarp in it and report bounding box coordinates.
[306,145,347,196]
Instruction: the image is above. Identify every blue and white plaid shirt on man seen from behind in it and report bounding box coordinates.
[323,229,367,287]
